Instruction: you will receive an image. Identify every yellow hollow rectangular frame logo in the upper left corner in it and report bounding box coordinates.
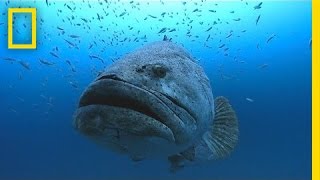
[8,8,37,49]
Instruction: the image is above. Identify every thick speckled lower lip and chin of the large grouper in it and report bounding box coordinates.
[75,105,175,143]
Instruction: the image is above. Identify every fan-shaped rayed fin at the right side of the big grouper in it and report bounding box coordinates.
[203,97,239,159]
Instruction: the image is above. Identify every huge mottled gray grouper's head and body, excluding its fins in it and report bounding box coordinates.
[74,41,214,160]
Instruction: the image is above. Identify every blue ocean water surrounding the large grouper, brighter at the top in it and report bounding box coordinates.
[0,0,311,180]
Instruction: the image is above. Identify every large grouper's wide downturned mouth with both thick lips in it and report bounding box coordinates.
[74,75,196,144]
